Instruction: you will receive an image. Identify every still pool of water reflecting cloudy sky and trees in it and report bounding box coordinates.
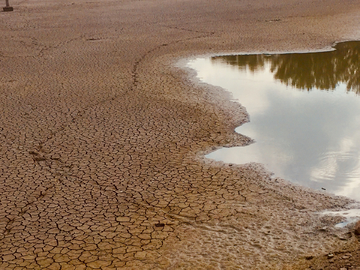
[189,42,360,200]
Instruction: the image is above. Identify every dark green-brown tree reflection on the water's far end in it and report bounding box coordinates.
[212,41,360,94]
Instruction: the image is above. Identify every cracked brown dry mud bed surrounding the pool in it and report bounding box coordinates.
[0,0,360,269]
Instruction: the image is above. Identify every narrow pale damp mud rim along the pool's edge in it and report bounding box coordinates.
[179,49,359,234]
